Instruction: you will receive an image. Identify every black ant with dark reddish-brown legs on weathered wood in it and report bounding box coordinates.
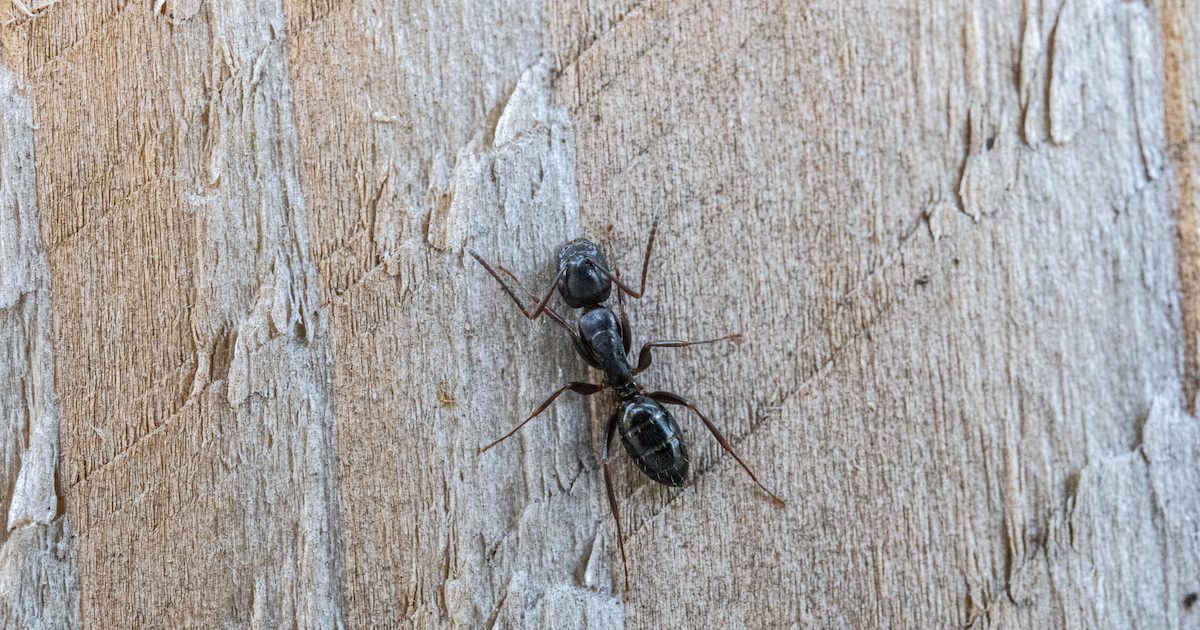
[467,218,784,593]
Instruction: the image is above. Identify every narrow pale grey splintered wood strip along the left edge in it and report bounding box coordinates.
[0,68,79,629]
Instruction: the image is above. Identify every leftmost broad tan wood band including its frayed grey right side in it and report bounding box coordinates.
[6,1,341,628]
